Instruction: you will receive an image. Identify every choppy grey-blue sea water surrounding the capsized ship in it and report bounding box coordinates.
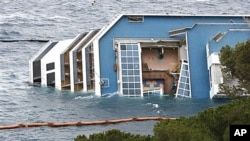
[0,0,250,141]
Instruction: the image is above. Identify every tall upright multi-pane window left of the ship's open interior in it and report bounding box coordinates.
[120,43,142,96]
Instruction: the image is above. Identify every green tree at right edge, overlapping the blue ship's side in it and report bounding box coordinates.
[219,40,250,96]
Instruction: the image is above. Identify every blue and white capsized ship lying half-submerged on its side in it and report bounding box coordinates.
[29,14,250,98]
